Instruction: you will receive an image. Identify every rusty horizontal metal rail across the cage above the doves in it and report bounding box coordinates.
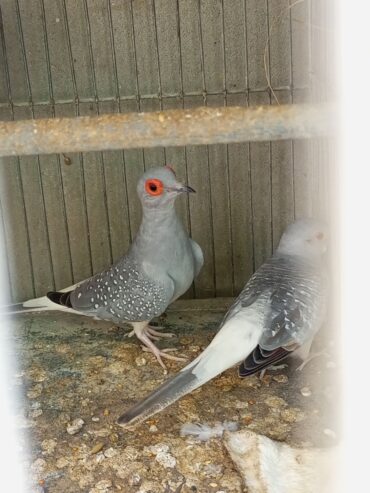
[0,104,333,156]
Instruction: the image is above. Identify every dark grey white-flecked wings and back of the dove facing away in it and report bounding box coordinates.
[229,257,324,376]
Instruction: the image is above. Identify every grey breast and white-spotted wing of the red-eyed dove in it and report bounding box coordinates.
[71,208,196,323]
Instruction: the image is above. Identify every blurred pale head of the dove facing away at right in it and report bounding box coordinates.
[277,219,328,258]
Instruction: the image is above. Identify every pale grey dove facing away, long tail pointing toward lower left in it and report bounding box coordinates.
[118,219,327,427]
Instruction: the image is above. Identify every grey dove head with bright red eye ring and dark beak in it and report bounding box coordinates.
[137,166,195,208]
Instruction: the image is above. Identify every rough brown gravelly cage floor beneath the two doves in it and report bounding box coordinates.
[12,299,339,493]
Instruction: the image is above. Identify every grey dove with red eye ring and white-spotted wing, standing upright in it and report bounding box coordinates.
[7,166,203,368]
